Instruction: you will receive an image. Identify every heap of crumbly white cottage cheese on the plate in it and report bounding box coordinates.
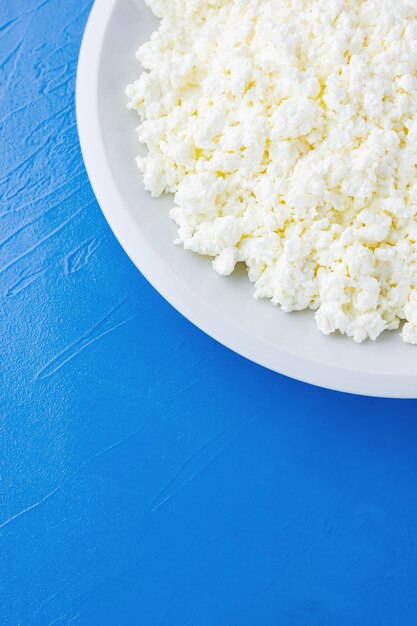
[127,0,417,344]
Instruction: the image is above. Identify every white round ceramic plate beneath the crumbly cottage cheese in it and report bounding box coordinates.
[77,0,417,398]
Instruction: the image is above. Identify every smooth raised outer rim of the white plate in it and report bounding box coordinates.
[76,0,417,399]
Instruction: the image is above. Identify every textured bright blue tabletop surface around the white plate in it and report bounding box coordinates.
[0,0,417,626]
